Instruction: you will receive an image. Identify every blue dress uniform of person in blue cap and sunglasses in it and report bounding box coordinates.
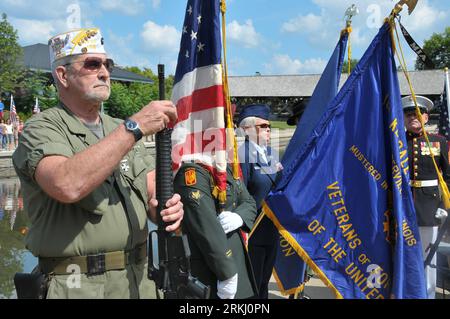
[239,140,279,299]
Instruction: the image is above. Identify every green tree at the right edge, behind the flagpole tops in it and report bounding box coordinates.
[416,27,450,70]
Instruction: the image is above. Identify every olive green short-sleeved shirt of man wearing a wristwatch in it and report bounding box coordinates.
[13,105,154,257]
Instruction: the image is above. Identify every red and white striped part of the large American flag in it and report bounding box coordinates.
[172,64,227,189]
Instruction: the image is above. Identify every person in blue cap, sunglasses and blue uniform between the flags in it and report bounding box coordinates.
[238,104,281,299]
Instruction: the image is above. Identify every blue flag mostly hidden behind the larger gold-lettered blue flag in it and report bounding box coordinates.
[273,31,348,294]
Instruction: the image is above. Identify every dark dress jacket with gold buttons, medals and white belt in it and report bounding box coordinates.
[407,132,450,226]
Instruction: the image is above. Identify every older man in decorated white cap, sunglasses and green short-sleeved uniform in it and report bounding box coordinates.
[13,28,183,298]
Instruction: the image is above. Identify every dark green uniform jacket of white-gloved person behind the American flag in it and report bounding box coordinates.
[174,163,256,299]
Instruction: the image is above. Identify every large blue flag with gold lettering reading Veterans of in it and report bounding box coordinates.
[263,23,426,299]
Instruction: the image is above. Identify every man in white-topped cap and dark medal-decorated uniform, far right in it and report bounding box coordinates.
[402,96,450,299]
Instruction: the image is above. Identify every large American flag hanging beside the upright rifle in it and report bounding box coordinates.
[172,0,227,200]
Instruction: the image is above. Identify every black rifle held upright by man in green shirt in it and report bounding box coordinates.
[148,64,210,299]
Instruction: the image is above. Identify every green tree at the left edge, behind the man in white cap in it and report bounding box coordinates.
[0,13,23,94]
